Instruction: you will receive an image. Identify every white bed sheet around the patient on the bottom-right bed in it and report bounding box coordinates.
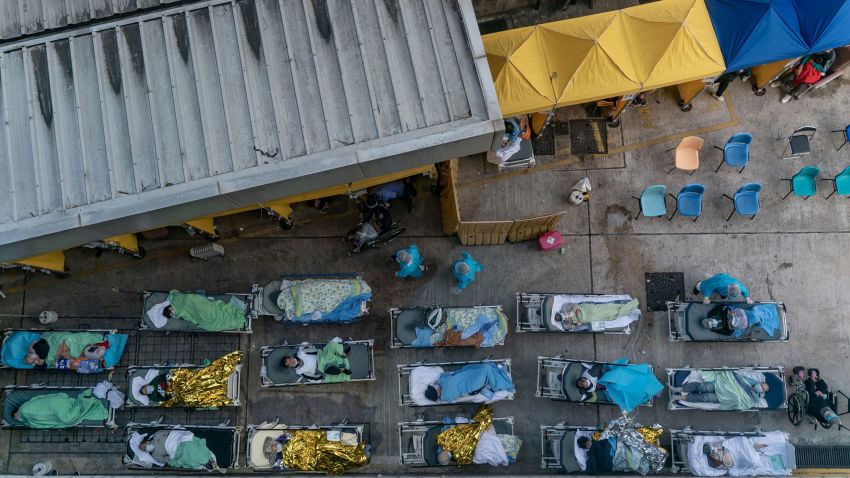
[688,431,793,476]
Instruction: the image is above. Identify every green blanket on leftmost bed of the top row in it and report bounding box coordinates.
[168,290,245,332]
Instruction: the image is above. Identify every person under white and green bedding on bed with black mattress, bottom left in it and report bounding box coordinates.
[130,430,218,470]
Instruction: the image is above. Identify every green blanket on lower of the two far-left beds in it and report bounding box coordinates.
[18,389,109,428]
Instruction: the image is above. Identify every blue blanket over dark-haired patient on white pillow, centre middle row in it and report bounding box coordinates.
[437,363,514,402]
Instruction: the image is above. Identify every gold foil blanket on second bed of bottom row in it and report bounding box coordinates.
[283,430,368,475]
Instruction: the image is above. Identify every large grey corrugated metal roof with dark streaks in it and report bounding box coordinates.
[0,0,500,260]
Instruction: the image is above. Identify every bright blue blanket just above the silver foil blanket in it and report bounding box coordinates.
[599,359,664,412]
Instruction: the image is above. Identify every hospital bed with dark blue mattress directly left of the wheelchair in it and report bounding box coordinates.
[667,365,788,412]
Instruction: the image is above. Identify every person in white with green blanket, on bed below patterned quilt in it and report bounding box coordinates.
[282,337,351,382]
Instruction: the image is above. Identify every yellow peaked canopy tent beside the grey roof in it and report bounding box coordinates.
[483,0,726,117]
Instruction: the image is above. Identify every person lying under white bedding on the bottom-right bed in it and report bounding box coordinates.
[688,431,791,476]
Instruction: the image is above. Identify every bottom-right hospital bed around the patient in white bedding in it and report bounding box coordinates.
[670,427,797,476]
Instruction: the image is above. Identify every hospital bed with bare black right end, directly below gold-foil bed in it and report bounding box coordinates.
[122,422,242,473]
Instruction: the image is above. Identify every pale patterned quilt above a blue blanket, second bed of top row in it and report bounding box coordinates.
[277,279,371,319]
